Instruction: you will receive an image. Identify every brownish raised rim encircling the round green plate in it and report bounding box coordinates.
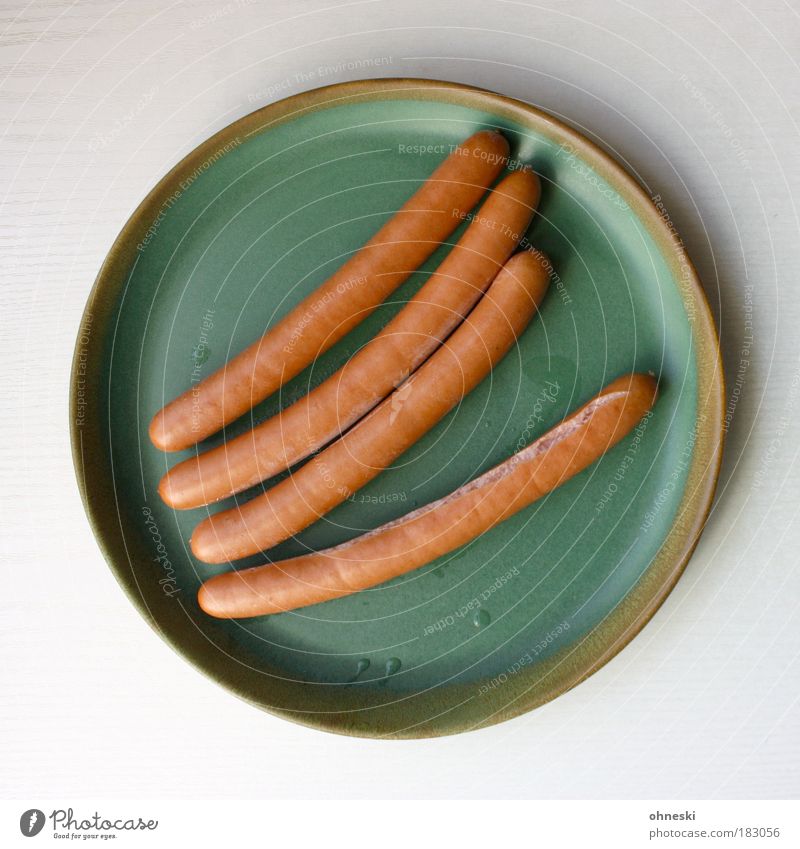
[69,77,725,739]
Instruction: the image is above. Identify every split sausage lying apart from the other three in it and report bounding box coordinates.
[198,374,657,618]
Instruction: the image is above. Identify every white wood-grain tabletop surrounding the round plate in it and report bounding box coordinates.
[0,0,800,799]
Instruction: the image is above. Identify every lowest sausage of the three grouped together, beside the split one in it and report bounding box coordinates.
[191,251,550,563]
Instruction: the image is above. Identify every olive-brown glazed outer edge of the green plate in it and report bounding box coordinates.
[69,78,724,739]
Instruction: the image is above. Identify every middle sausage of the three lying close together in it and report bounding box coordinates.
[158,171,540,510]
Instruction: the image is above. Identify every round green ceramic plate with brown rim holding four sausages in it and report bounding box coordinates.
[71,80,722,737]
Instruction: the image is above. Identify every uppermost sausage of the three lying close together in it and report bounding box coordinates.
[150,130,508,451]
